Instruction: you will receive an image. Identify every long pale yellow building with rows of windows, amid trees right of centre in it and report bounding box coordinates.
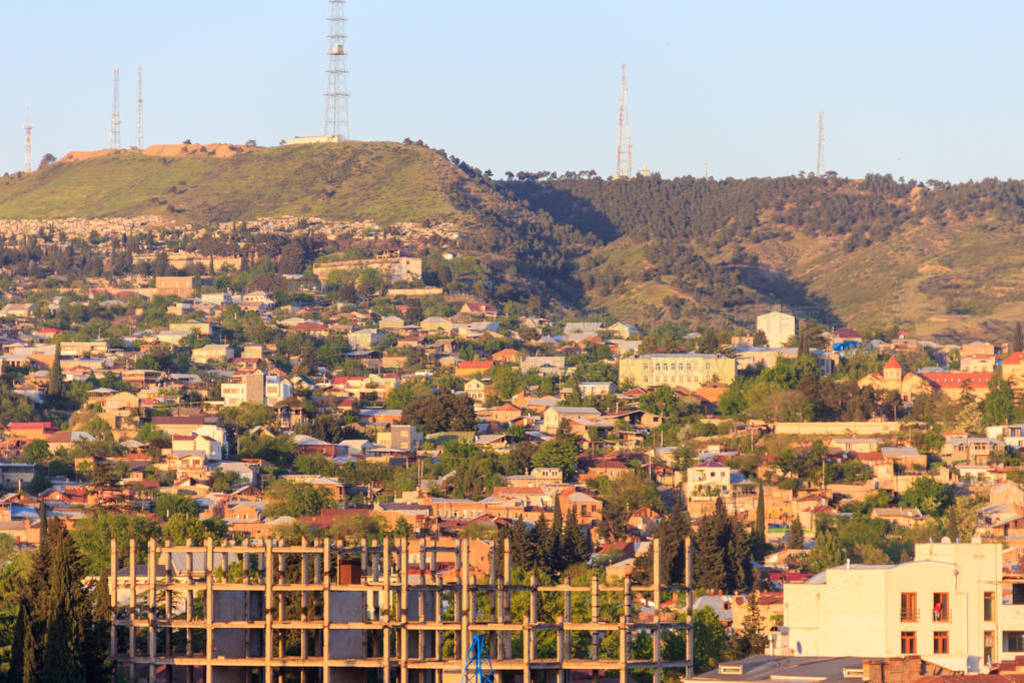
[618,353,736,390]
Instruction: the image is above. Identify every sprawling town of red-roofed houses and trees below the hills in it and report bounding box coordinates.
[6,221,1024,672]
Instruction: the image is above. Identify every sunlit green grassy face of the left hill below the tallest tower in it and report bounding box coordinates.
[0,142,461,223]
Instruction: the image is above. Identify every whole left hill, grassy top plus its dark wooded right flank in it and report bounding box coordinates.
[0,141,596,303]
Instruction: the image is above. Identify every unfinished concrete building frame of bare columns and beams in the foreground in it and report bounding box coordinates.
[110,538,693,683]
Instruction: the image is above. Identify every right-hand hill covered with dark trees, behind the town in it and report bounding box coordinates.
[501,173,1024,336]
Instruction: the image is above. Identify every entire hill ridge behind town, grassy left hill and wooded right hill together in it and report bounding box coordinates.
[0,141,1024,337]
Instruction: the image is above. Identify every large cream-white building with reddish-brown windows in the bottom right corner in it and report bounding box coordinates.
[781,539,1024,673]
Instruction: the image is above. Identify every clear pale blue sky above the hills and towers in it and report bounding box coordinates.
[0,0,1024,180]
